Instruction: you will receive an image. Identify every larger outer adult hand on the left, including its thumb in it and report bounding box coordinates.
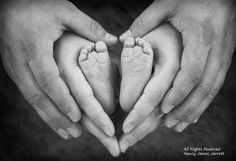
[0,0,117,139]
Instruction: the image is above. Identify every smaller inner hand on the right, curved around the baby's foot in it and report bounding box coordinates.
[119,24,182,152]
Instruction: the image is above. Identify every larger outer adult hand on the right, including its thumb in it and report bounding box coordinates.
[120,0,236,132]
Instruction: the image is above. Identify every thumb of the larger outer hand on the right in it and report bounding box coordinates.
[120,0,174,42]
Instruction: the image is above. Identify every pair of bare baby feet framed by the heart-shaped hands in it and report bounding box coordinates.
[78,37,153,114]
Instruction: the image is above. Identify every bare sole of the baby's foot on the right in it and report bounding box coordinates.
[120,37,153,111]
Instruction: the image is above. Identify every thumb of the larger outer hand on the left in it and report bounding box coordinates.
[60,2,118,45]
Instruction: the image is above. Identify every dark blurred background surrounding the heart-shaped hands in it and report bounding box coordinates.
[0,0,236,161]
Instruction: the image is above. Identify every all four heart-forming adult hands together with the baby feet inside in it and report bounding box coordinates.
[0,0,236,155]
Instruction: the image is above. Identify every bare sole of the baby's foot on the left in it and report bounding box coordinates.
[78,41,115,114]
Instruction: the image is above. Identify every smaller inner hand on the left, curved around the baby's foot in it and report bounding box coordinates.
[54,32,120,156]
